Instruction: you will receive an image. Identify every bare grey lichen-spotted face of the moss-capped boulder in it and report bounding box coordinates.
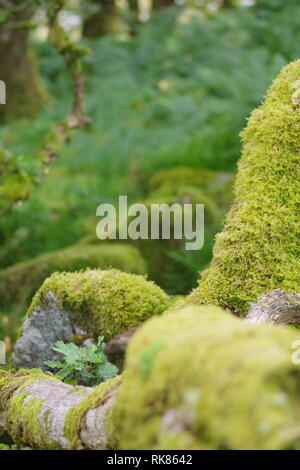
[13,292,90,370]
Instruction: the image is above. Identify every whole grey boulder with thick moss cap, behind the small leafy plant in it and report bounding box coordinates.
[14,269,169,368]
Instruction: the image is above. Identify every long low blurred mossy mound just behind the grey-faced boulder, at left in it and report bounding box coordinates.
[0,242,146,310]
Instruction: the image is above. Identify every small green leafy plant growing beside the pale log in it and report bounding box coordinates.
[44,336,119,386]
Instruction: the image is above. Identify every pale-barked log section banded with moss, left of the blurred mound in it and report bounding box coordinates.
[0,369,120,450]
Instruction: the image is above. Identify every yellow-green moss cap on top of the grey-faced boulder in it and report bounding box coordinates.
[28,269,169,341]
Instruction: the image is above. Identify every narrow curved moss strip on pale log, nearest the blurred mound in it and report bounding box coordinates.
[65,376,121,449]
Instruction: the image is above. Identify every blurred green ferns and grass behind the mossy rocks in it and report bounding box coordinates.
[0,0,300,298]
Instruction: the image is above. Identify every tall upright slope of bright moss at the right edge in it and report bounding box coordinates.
[188,61,300,315]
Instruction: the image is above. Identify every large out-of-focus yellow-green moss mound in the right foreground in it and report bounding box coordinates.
[110,306,300,450]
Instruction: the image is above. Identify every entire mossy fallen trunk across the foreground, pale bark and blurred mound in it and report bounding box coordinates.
[0,298,300,450]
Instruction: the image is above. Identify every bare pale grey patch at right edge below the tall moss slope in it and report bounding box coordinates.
[246,289,300,325]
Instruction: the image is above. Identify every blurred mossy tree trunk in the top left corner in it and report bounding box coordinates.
[0,0,47,122]
